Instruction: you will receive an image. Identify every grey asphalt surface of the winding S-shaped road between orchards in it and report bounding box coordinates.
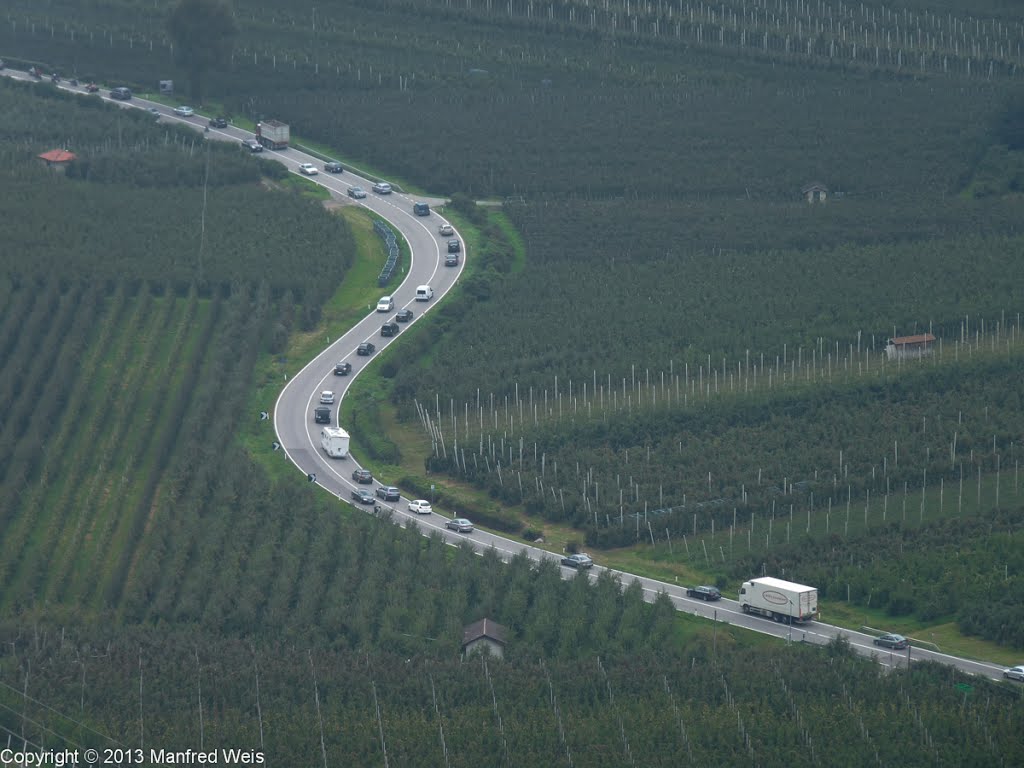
[3,70,1004,680]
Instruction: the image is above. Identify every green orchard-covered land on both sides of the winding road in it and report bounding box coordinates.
[0,0,1024,767]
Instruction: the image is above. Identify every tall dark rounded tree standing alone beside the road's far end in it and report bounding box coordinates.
[167,0,239,103]
